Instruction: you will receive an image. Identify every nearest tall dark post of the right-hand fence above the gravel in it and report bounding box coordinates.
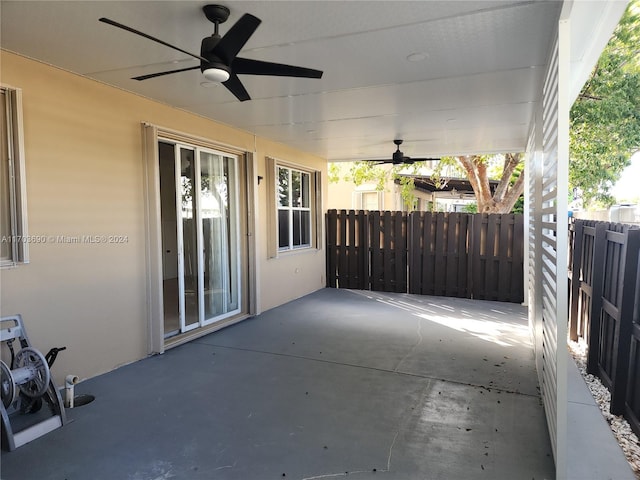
[610,229,640,415]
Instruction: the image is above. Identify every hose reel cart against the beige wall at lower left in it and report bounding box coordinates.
[0,315,67,451]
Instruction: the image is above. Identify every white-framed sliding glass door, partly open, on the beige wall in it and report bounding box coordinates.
[158,141,241,338]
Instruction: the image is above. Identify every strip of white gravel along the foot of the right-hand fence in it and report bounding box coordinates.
[569,341,640,480]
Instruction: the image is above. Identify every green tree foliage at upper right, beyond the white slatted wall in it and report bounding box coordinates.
[569,0,640,205]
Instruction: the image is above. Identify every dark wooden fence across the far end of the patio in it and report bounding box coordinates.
[326,210,524,302]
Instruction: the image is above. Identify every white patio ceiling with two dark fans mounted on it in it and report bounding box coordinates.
[0,0,576,160]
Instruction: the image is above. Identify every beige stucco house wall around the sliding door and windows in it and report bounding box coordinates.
[0,51,326,384]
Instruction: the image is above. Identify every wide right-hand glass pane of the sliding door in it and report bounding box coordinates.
[200,151,239,321]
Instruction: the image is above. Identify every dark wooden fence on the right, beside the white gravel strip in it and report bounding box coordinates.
[569,220,640,435]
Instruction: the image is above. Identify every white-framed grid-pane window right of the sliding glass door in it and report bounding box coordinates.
[276,165,312,251]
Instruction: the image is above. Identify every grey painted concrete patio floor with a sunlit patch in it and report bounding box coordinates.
[1,289,555,480]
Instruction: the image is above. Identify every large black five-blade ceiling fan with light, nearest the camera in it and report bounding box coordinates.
[99,5,323,102]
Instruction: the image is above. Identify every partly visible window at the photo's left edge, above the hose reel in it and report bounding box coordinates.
[0,85,32,267]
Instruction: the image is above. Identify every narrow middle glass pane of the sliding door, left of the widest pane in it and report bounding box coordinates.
[178,148,199,329]
